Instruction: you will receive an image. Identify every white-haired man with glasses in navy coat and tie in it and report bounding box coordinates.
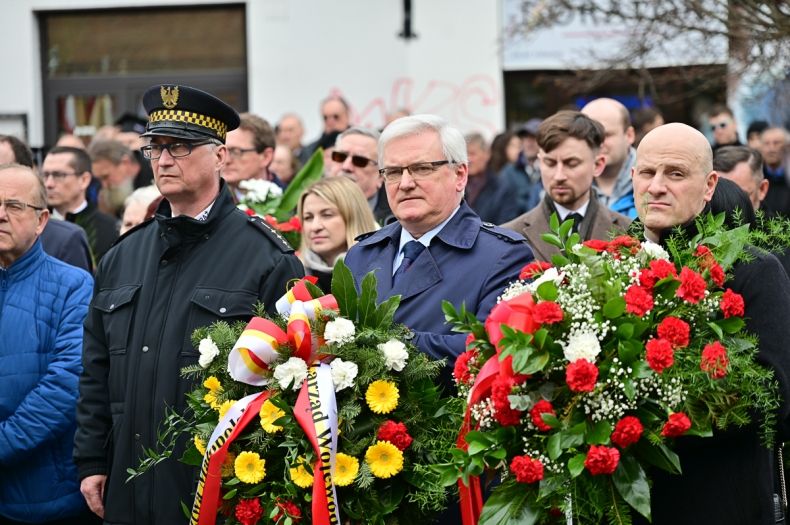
[345,115,533,366]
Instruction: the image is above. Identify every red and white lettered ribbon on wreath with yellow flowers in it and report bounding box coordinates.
[190,278,339,525]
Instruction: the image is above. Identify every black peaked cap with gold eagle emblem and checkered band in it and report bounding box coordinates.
[142,84,239,143]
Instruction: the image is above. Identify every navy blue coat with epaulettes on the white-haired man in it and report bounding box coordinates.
[345,202,533,366]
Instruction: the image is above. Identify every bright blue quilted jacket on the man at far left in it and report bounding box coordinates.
[0,240,93,523]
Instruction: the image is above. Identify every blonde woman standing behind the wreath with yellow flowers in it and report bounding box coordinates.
[297,176,379,293]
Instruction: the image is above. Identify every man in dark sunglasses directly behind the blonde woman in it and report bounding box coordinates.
[330,127,392,224]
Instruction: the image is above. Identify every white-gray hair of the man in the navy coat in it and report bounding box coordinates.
[378,114,468,166]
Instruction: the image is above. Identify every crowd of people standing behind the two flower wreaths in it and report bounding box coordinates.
[0,81,790,525]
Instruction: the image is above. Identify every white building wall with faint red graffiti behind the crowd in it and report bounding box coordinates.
[0,0,504,146]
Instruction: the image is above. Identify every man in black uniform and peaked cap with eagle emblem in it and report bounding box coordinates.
[74,85,303,525]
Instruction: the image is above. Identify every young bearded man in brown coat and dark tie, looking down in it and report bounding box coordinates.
[502,111,631,261]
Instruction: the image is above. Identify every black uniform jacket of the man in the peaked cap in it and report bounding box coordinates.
[74,182,303,525]
